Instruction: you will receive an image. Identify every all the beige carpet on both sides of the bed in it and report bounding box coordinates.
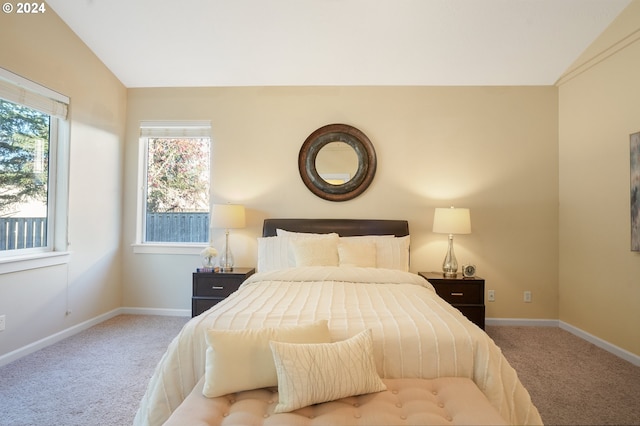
[0,315,640,426]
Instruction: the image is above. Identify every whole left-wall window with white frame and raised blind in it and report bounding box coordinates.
[0,68,69,259]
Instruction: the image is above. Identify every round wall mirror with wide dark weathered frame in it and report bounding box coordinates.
[298,124,376,201]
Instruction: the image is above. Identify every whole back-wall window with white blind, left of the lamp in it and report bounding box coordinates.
[138,122,211,244]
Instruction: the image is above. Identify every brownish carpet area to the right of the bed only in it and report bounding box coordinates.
[487,326,640,425]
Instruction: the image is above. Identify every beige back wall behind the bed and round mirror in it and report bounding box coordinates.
[123,87,558,319]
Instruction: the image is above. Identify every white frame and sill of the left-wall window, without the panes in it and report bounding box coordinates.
[0,68,70,274]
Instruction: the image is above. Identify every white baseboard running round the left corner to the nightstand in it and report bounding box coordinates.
[0,308,191,367]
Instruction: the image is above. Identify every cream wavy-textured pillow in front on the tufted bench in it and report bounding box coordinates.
[270,330,387,413]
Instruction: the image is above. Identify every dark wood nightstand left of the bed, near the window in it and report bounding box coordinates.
[191,268,256,317]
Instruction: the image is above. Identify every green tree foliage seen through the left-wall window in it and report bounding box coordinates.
[0,99,49,213]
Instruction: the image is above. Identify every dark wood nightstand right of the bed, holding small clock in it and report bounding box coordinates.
[418,272,484,330]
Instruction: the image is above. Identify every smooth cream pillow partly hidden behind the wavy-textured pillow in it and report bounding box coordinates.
[202,320,331,398]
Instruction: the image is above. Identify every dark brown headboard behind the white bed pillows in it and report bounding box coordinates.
[262,219,409,237]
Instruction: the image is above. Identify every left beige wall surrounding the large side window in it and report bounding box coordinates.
[0,8,126,356]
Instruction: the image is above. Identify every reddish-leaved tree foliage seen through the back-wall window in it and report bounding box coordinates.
[147,138,209,213]
